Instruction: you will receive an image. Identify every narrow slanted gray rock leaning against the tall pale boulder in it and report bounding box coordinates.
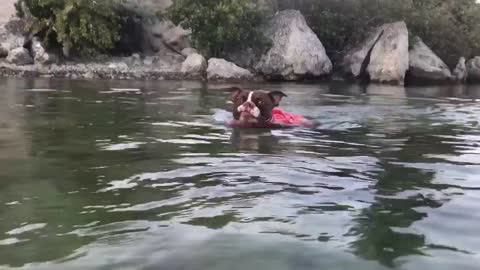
[342,27,383,78]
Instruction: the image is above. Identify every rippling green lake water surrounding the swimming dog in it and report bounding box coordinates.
[0,79,480,270]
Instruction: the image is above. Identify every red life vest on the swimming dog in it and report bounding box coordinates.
[230,109,314,128]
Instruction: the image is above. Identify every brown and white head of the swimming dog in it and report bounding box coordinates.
[231,87,287,123]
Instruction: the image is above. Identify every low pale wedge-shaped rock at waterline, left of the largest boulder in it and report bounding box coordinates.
[207,58,253,80]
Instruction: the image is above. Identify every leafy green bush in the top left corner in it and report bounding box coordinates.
[17,0,121,56]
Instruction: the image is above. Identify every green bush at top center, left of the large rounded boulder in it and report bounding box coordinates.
[166,0,265,57]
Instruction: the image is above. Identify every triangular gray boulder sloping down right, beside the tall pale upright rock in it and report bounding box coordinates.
[408,37,452,82]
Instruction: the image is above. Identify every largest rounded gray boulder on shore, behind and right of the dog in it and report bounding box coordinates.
[256,10,332,80]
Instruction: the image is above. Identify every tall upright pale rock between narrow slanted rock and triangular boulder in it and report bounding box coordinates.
[367,22,409,85]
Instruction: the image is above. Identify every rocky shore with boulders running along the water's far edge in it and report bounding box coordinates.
[0,0,480,85]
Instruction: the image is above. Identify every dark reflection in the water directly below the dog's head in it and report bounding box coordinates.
[230,129,279,153]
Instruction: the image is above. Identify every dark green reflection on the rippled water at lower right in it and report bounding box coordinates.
[348,137,455,267]
